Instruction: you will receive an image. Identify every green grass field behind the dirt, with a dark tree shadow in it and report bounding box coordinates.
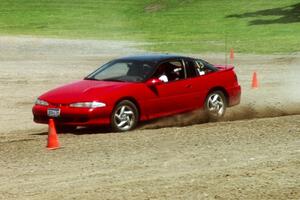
[0,0,300,53]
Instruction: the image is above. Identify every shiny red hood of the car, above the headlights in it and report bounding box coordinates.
[39,80,132,104]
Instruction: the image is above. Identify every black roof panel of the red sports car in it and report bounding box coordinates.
[117,54,189,63]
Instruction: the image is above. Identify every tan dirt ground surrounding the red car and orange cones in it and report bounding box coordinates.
[0,36,300,199]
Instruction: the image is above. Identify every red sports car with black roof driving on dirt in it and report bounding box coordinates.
[32,54,241,131]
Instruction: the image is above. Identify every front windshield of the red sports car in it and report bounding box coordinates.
[85,60,154,82]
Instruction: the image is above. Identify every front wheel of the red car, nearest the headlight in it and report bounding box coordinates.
[110,100,139,132]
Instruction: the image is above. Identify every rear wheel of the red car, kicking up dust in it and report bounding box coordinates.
[205,90,227,121]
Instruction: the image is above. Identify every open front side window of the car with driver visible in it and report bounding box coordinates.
[153,60,185,82]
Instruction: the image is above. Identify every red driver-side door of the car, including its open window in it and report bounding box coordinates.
[145,59,192,117]
